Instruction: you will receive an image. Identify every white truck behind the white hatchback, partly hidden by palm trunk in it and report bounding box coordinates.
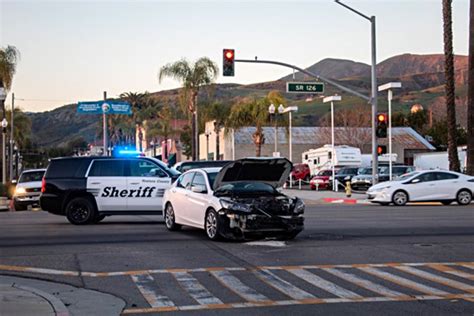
[413,146,467,171]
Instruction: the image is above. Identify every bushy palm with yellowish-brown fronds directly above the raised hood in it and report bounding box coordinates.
[226,98,269,157]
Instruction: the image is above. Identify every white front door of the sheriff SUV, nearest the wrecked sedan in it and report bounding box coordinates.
[127,159,171,211]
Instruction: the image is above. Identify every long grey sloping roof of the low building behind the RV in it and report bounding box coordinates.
[234,127,436,150]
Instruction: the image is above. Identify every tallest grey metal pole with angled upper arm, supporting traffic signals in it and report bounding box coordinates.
[334,0,378,184]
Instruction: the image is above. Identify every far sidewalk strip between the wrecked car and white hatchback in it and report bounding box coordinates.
[282,188,370,205]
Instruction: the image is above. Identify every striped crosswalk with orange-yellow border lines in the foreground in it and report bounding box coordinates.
[0,262,474,314]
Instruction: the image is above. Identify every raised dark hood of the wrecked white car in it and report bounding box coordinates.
[213,158,293,190]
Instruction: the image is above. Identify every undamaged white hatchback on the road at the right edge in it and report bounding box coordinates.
[367,170,474,206]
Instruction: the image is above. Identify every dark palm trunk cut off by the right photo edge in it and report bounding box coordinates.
[466,0,474,175]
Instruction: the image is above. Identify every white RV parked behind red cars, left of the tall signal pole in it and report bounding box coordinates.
[302,145,361,175]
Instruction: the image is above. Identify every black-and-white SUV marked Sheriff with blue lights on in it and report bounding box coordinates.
[40,157,179,225]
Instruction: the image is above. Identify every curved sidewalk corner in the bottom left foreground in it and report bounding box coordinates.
[0,275,125,316]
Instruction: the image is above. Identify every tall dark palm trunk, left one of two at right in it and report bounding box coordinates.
[443,0,460,171]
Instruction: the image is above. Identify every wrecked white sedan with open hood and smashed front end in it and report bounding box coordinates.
[163,158,305,240]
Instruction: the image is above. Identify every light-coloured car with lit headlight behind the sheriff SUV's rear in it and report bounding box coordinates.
[13,169,46,211]
